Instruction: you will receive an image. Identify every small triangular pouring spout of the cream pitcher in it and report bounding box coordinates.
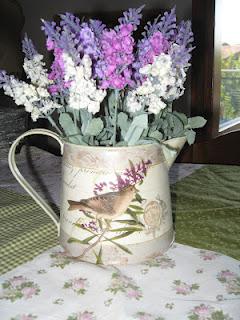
[162,137,187,169]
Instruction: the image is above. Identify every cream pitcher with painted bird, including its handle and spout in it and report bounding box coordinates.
[9,129,186,264]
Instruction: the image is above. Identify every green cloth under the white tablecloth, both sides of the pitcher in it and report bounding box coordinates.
[0,165,240,273]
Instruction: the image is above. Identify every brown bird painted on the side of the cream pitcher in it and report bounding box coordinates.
[68,185,137,220]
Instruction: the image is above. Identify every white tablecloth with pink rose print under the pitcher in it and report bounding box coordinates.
[0,244,240,320]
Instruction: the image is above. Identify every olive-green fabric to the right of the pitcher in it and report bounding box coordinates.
[172,165,240,259]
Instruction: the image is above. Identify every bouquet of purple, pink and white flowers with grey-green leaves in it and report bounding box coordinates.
[0,6,206,146]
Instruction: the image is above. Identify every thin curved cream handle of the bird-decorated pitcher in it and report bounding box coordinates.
[8,129,64,235]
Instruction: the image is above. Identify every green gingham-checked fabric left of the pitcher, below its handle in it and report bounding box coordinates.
[0,188,58,274]
